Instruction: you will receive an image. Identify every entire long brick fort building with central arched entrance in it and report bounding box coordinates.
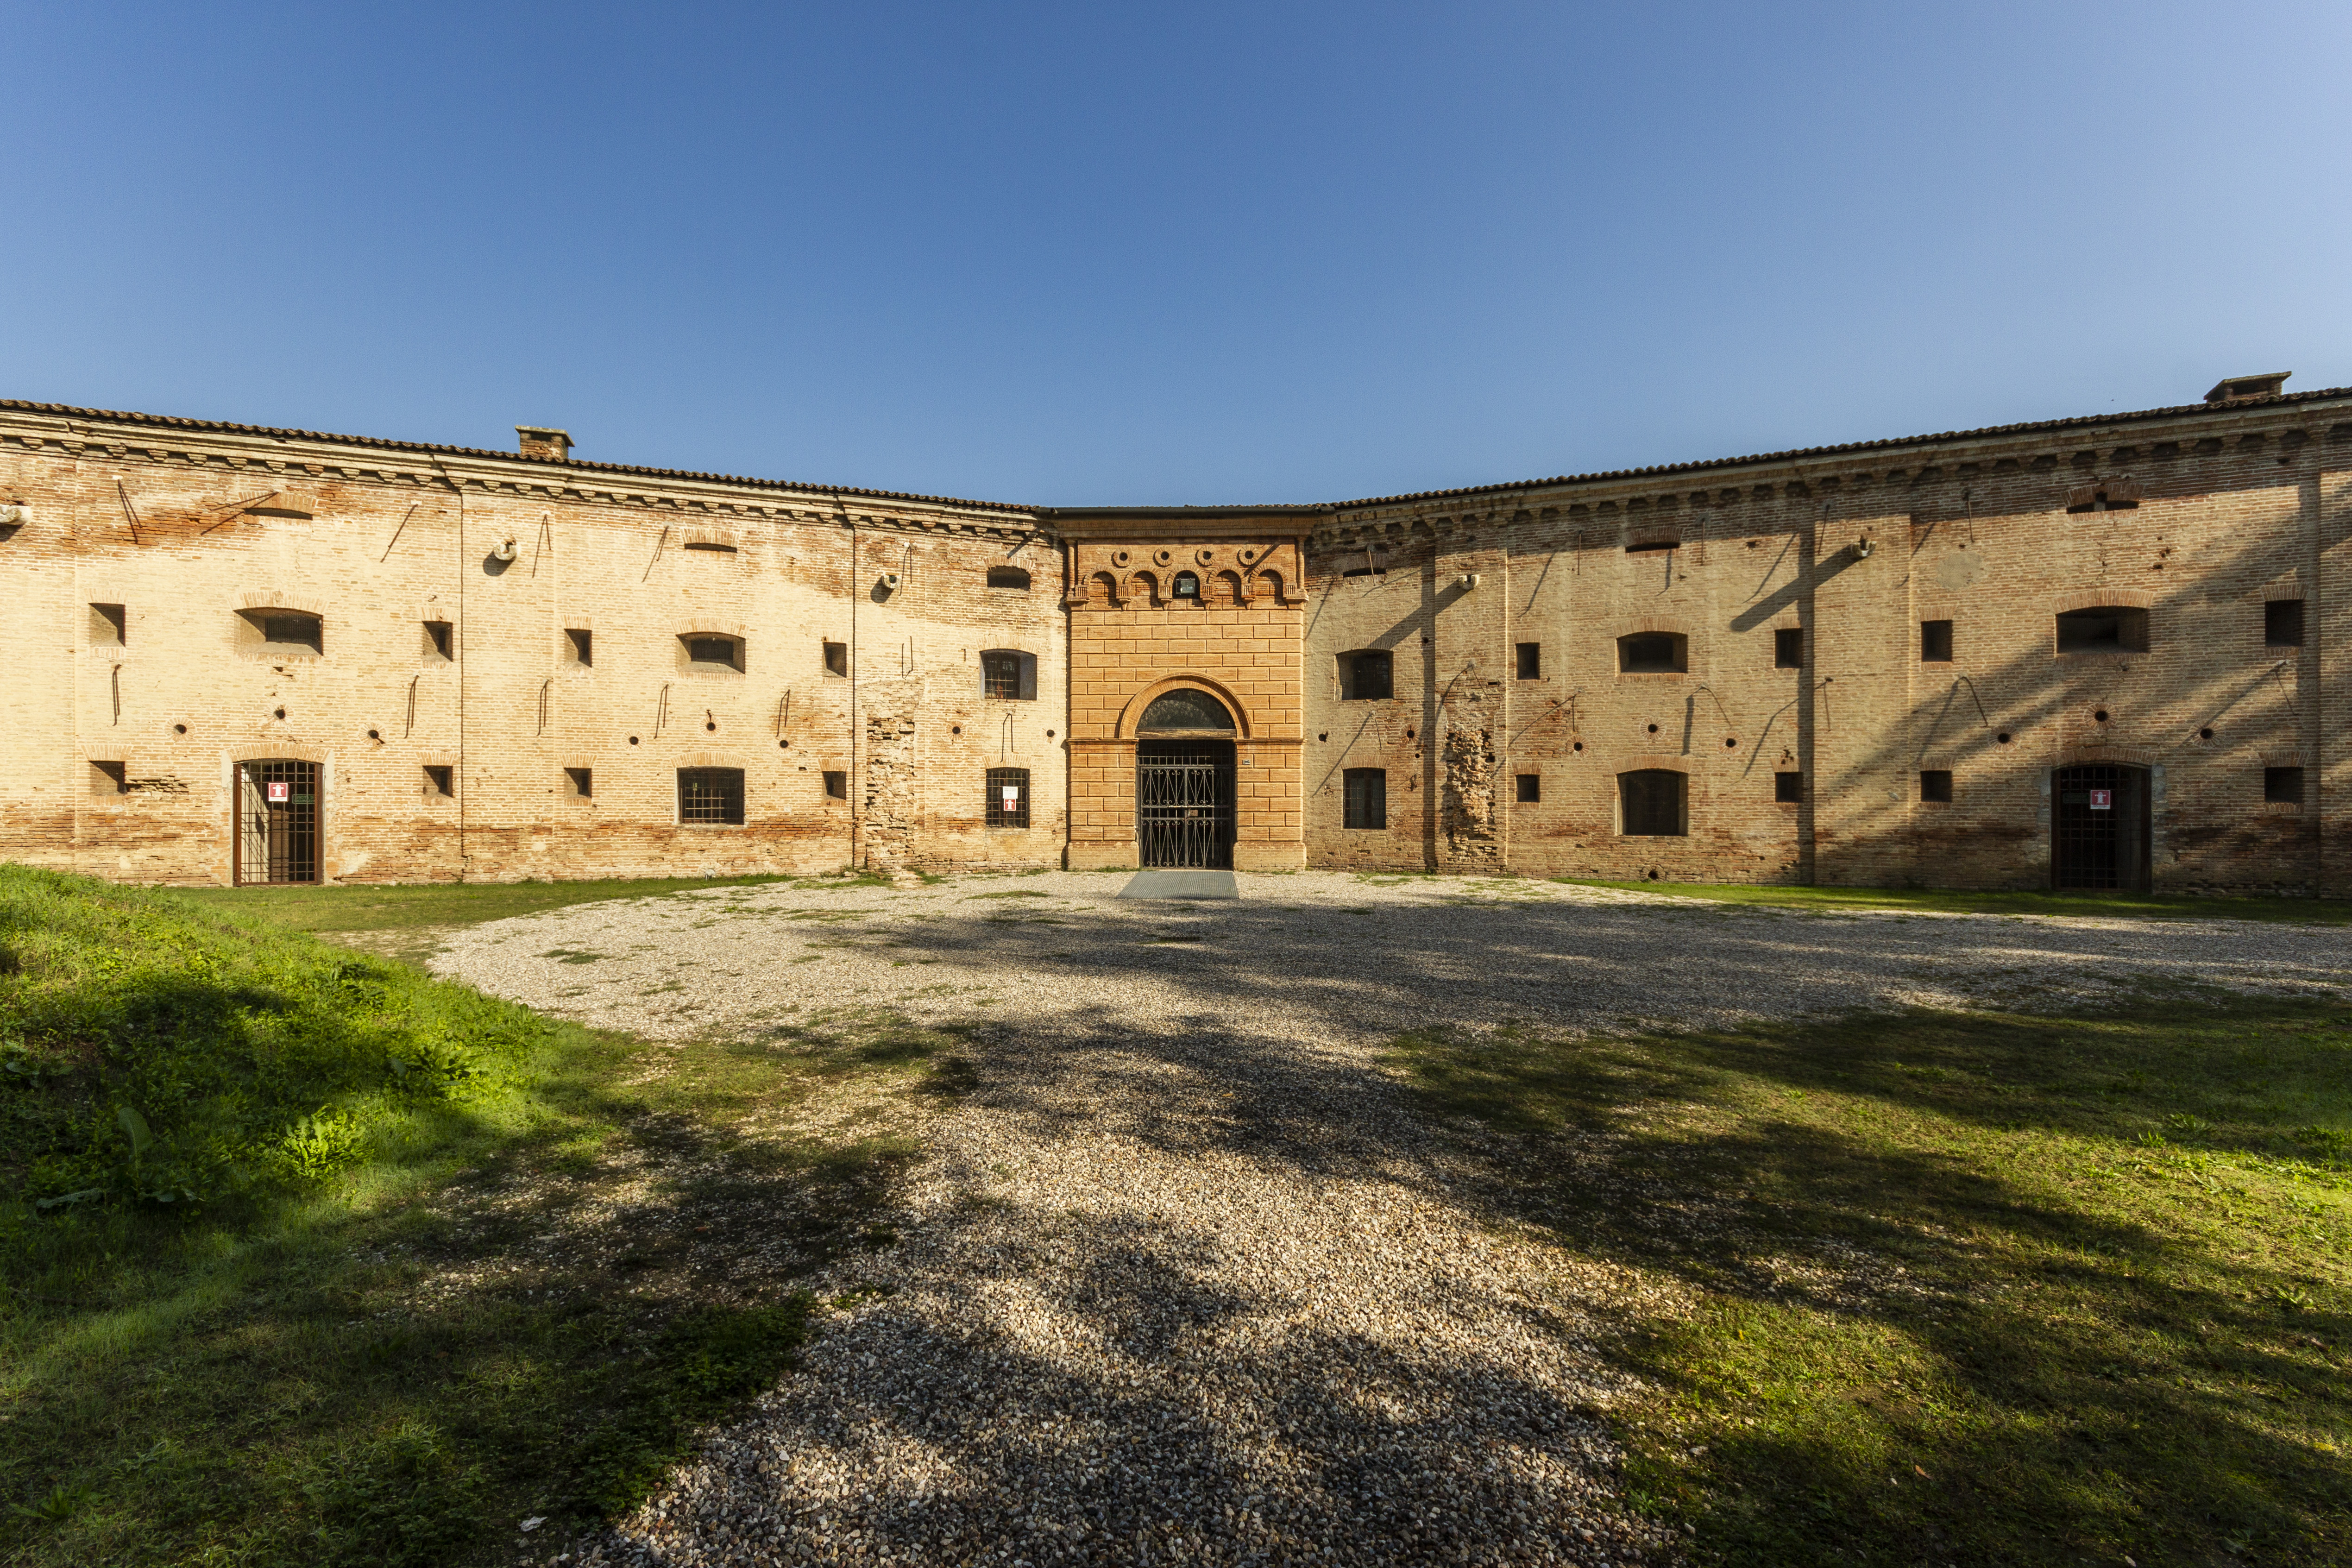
[0,376,2352,893]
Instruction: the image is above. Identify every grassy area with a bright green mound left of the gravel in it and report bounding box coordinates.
[0,868,971,1568]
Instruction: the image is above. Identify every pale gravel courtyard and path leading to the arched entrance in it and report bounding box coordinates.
[435,872,2352,1566]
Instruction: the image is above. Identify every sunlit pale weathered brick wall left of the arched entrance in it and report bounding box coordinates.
[0,409,1065,882]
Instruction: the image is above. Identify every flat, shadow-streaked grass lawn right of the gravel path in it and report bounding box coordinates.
[1390,992,2352,1566]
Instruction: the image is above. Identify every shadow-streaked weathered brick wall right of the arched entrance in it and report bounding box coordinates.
[1305,402,2352,891]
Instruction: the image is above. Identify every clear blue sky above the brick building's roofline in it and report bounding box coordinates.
[0,0,2352,505]
